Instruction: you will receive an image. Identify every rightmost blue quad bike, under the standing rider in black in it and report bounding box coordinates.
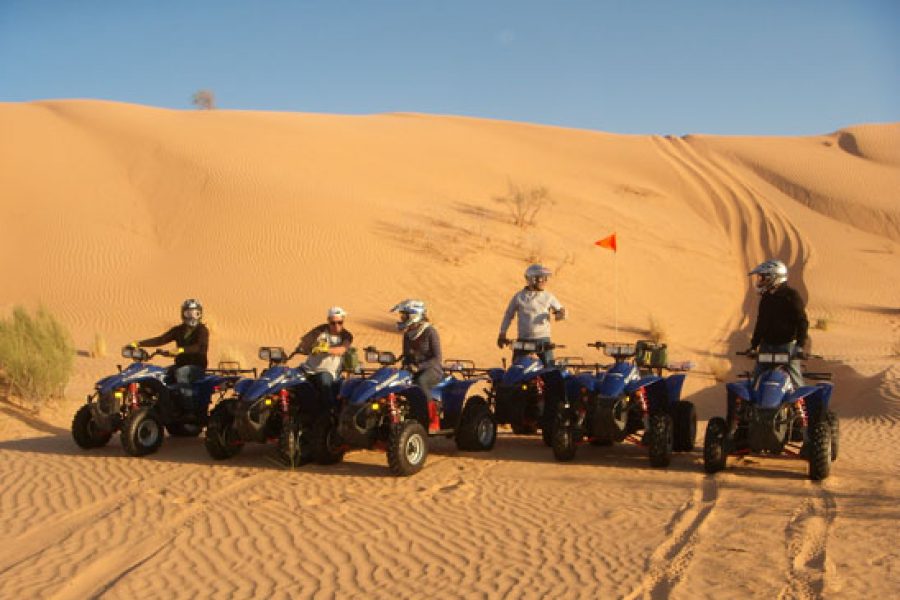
[703,352,840,481]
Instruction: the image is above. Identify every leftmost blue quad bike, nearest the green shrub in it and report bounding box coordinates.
[72,346,253,456]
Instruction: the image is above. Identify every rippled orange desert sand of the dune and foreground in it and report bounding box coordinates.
[0,100,900,599]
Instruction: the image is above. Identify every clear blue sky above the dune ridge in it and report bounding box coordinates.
[0,0,900,134]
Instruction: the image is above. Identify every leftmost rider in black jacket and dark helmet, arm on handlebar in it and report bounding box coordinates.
[132,298,209,399]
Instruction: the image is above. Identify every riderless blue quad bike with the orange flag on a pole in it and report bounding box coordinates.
[552,340,697,467]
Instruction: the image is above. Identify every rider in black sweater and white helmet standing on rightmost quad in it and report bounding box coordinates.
[749,260,809,387]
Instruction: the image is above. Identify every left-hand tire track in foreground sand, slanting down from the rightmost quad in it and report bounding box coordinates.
[625,476,719,600]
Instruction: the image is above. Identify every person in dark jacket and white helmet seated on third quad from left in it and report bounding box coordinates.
[391,300,444,414]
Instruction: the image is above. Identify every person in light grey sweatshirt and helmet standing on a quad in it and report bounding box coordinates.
[497,265,566,366]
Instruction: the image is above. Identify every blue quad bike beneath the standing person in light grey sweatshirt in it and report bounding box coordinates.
[487,340,570,446]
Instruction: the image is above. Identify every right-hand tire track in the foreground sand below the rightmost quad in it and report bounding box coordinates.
[778,489,837,600]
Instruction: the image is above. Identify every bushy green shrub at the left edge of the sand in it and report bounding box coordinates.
[0,306,75,402]
